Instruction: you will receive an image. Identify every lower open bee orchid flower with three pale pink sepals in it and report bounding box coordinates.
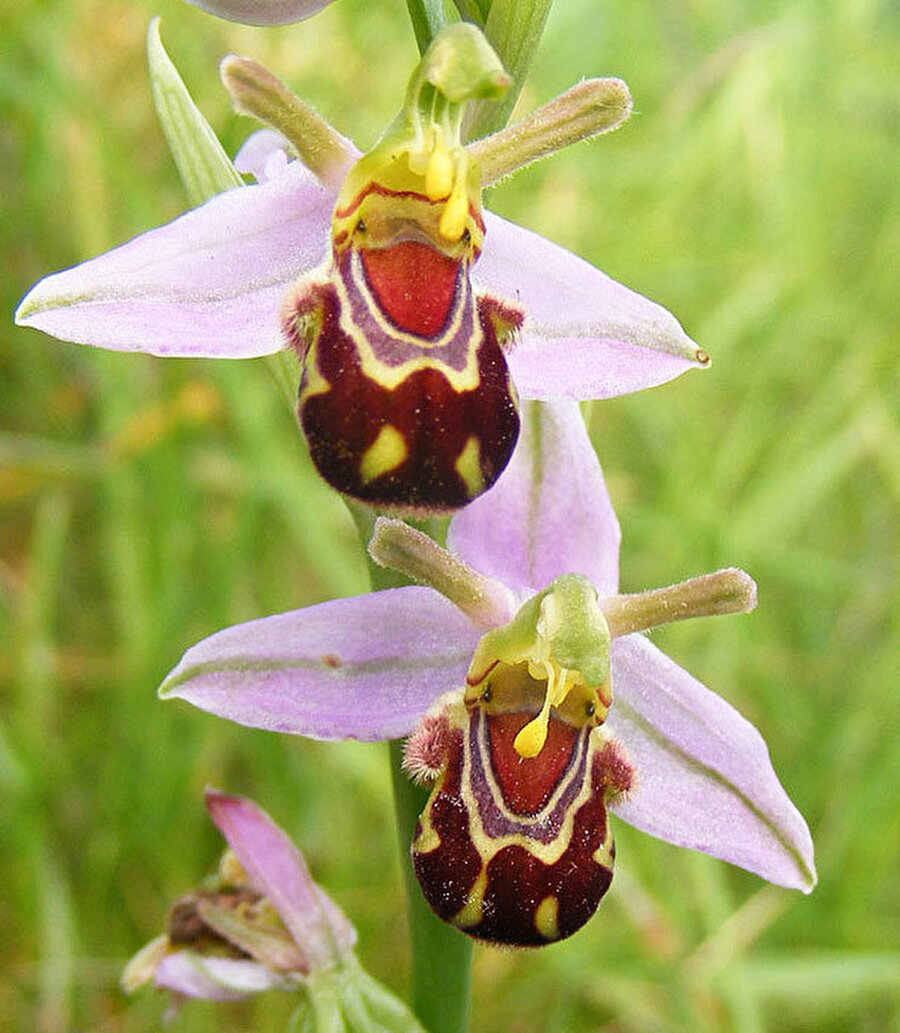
[160,403,815,945]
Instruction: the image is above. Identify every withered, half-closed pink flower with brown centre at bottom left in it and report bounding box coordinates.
[122,789,422,1033]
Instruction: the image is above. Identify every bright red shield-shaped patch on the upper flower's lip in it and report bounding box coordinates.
[361,241,460,337]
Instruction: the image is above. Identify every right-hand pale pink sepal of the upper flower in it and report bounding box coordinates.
[473,214,709,399]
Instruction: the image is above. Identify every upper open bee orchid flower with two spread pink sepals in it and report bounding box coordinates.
[10,24,708,513]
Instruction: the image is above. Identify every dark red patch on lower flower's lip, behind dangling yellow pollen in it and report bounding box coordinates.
[488,712,578,815]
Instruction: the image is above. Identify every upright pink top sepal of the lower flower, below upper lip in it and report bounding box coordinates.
[447,402,621,596]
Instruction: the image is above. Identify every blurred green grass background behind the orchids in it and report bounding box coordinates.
[0,0,900,1033]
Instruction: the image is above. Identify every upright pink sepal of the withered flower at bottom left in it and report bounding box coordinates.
[206,789,355,970]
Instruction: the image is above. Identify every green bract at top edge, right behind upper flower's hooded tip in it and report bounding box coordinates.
[465,0,553,139]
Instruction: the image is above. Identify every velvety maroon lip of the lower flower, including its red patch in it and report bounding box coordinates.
[412,705,631,946]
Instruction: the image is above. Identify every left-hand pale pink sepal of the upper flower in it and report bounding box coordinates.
[15,162,334,358]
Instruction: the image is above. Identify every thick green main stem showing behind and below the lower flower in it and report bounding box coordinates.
[357,524,472,1033]
